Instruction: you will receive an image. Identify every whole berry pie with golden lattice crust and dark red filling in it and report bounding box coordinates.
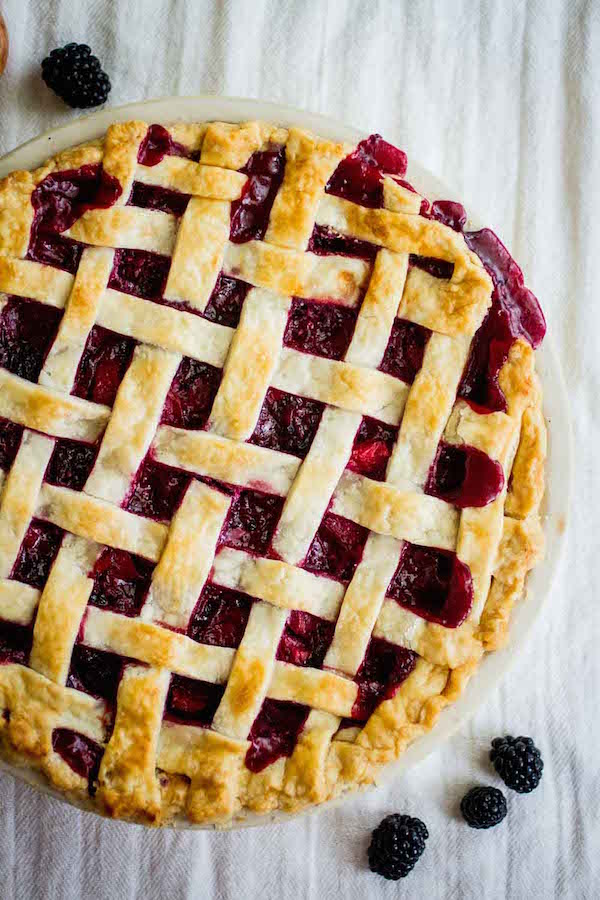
[0,121,546,825]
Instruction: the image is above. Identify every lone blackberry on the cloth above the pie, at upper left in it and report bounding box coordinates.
[42,44,110,109]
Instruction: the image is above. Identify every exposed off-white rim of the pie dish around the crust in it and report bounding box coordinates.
[0,95,572,828]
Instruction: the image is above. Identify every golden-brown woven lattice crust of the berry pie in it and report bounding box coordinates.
[0,116,546,825]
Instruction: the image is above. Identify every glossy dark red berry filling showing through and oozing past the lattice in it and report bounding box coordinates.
[0,125,545,791]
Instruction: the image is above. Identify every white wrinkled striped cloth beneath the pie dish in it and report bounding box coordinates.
[0,0,600,900]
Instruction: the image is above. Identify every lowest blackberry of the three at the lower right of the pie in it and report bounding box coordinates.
[368,814,429,881]
